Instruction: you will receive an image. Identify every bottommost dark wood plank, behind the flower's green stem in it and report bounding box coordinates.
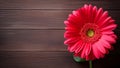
[0,52,120,68]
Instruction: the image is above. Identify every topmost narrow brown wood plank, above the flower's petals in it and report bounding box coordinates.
[0,0,120,9]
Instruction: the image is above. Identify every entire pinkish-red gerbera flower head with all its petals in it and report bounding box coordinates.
[64,4,117,60]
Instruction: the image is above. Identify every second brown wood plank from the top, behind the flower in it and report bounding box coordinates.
[0,10,120,29]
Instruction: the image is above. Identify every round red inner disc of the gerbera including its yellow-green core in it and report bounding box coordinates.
[79,23,101,43]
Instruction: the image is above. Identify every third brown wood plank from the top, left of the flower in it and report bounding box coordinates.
[0,30,66,51]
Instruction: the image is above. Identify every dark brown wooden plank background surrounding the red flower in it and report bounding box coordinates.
[0,0,120,68]
